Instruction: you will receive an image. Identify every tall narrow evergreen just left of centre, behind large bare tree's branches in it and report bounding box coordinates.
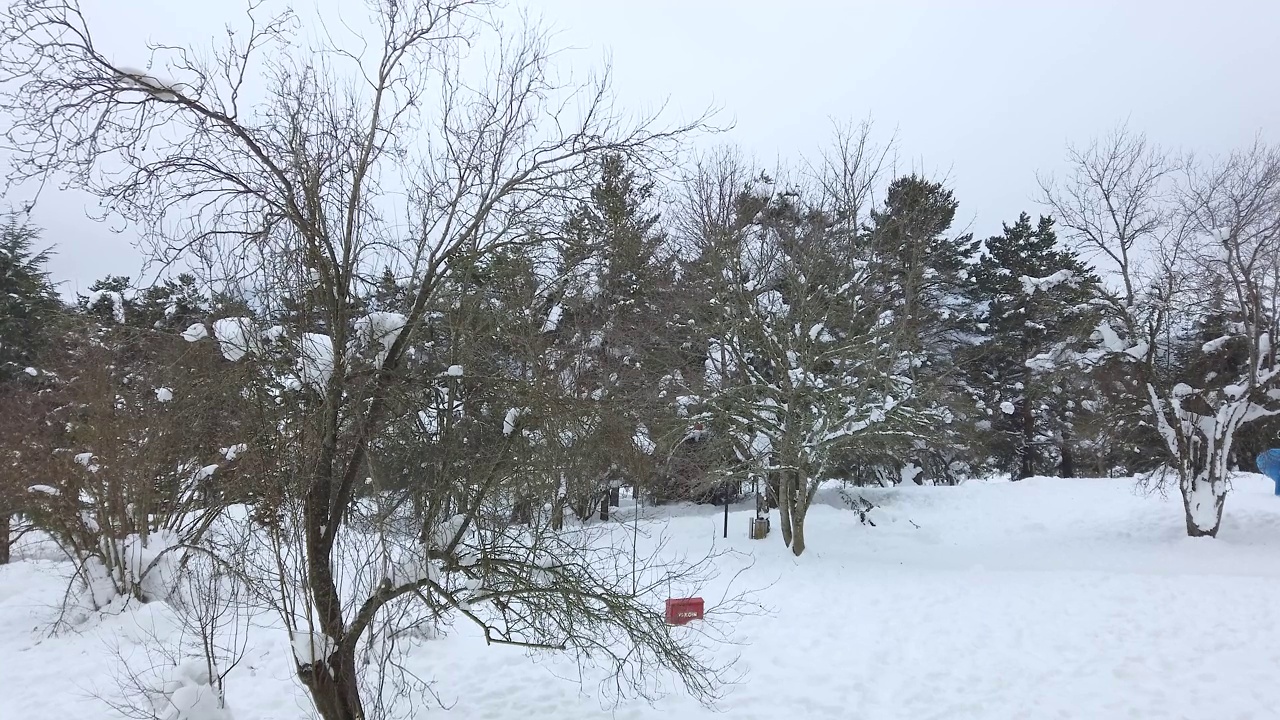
[544,155,672,516]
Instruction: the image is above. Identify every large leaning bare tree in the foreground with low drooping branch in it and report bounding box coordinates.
[0,0,732,720]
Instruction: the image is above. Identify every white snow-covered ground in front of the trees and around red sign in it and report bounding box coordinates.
[0,475,1280,720]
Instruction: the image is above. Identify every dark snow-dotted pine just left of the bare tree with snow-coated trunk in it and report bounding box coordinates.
[965,213,1098,479]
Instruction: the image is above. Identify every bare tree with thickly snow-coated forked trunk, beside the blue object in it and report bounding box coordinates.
[1046,131,1280,537]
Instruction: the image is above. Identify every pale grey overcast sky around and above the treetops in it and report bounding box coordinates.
[10,0,1280,292]
